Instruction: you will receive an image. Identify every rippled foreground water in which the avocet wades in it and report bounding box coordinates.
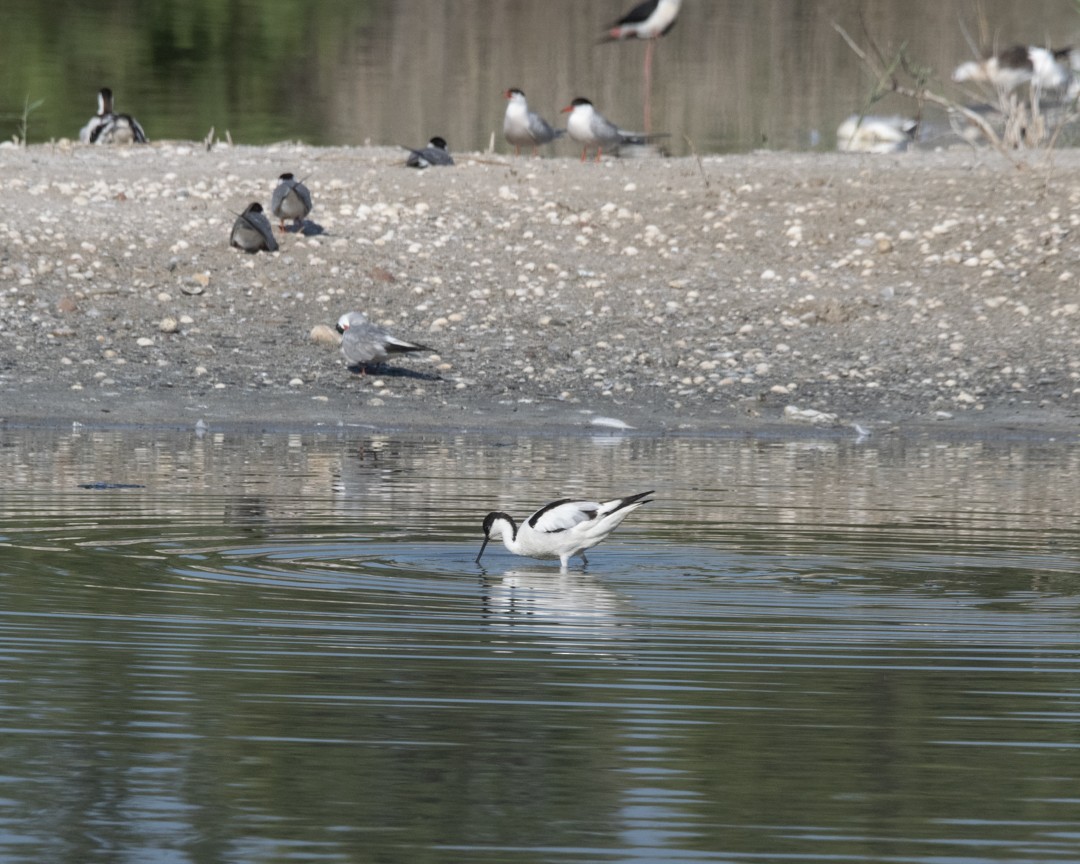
[0,430,1080,862]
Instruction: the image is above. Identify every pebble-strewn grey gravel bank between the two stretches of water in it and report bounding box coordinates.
[0,143,1080,435]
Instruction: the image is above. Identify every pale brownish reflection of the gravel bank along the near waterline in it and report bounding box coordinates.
[0,429,1080,546]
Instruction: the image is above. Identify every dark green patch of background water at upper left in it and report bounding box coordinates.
[0,0,372,143]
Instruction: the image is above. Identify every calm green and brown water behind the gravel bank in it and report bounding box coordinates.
[8,0,1080,156]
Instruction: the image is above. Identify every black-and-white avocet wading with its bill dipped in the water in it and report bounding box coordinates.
[476,489,652,570]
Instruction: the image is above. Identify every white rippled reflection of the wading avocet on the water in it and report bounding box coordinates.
[481,569,619,627]
